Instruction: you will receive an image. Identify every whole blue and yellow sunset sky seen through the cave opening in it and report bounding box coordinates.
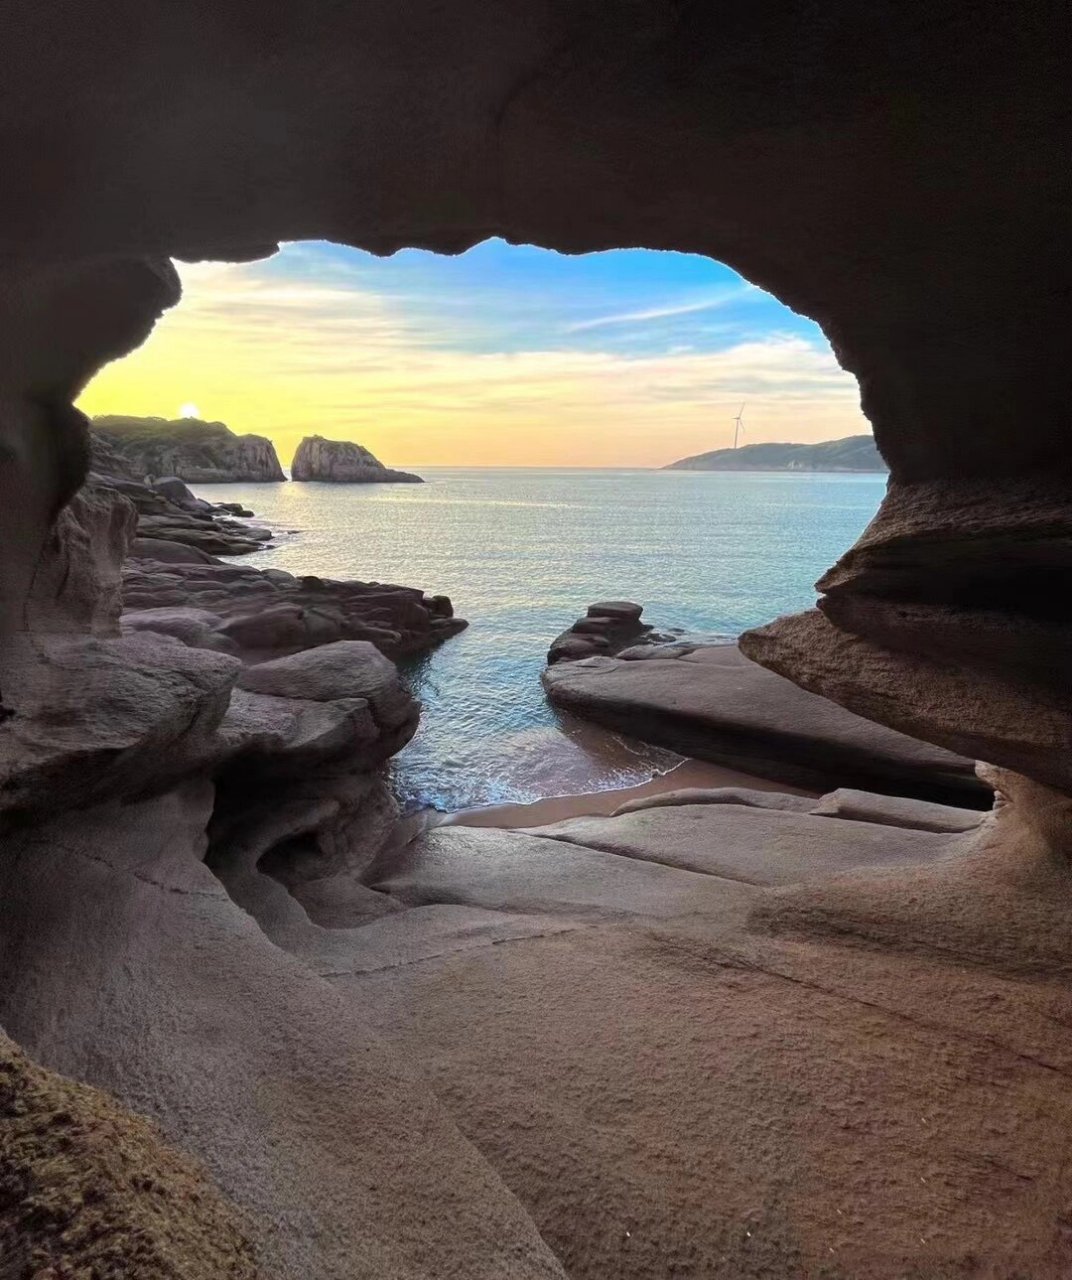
[79,239,869,467]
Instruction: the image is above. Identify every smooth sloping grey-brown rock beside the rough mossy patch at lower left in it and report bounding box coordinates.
[0,787,563,1280]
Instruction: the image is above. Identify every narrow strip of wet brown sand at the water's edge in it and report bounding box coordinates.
[443,760,817,827]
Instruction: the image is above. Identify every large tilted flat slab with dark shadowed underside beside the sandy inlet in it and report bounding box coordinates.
[544,645,989,806]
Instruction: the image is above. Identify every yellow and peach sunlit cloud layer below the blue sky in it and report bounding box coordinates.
[81,248,867,466]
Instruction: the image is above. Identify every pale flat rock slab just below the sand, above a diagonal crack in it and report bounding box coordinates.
[527,804,957,884]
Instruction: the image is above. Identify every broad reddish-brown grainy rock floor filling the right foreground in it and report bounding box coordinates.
[353,911,1072,1280]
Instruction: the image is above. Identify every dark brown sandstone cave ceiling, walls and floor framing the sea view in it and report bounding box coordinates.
[0,0,1072,1280]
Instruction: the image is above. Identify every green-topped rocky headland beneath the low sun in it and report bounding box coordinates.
[92,415,287,484]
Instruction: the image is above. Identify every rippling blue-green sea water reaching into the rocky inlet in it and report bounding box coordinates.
[198,467,885,810]
